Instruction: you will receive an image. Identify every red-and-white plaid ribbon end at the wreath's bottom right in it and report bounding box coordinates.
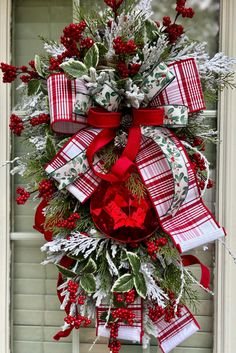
[156,306,200,353]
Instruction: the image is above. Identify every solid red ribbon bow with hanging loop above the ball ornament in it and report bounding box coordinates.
[86,108,165,183]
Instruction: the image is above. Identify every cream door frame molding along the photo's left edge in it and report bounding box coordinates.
[0,0,11,353]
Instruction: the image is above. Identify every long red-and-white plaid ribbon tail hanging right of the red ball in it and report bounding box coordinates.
[136,128,225,253]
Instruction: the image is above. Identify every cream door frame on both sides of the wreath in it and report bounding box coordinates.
[0,0,236,353]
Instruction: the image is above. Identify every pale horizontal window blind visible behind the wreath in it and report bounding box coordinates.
[12,0,218,353]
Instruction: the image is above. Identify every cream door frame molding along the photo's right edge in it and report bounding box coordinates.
[214,0,236,353]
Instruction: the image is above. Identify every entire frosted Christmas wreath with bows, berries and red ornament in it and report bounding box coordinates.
[0,0,235,353]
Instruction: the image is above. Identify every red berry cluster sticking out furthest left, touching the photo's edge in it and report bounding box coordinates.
[0,60,39,83]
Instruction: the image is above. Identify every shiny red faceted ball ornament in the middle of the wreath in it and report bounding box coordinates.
[90,181,159,243]
